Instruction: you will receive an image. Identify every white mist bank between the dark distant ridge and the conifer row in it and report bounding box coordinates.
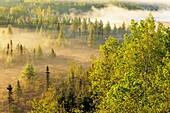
[78,5,170,27]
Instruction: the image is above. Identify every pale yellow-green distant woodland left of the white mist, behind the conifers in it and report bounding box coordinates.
[0,1,105,27]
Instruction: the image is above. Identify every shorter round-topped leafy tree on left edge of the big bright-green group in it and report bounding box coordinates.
[89,37,119,109]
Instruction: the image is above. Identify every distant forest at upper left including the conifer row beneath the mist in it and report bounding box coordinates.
[0,1,129,38]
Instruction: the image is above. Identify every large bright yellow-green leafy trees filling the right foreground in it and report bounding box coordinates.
[95,15,170,113]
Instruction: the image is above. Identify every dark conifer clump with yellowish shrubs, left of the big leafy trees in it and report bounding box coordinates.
[32,66,94,113]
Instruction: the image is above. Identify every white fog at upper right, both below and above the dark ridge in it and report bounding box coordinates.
[68,0,170,27]
